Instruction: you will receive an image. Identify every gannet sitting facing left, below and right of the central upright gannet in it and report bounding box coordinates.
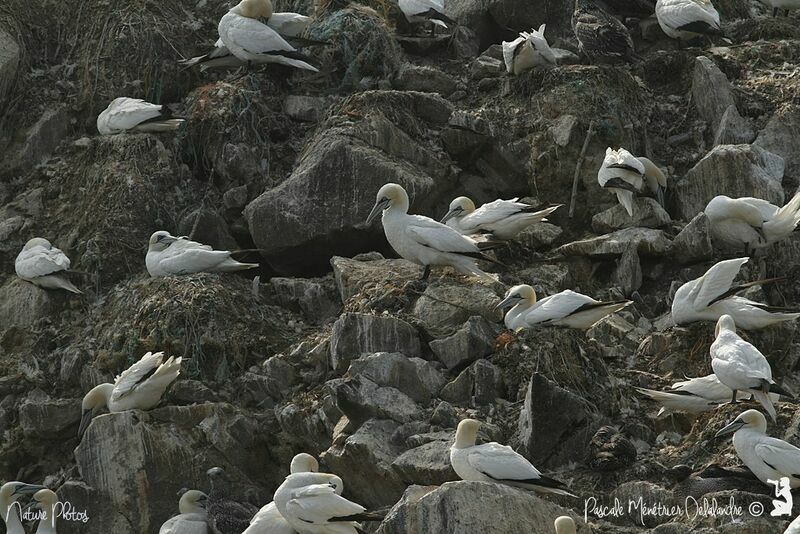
[497,284,633,330]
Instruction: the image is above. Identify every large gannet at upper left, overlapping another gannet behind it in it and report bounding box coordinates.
[217,0,317,72]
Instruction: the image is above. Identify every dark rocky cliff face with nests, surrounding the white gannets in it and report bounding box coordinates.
[0,0,800,534]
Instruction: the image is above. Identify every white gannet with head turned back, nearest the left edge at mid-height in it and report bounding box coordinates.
[14,237,81,294]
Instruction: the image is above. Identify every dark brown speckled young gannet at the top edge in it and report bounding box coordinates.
[572,0,637,61]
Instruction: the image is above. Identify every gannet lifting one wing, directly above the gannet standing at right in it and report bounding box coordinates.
[672,258,800,330]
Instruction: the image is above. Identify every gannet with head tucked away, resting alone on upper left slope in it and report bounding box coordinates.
[97,96,186,135]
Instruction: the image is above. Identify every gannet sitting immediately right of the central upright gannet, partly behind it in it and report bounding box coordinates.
[440,197,561,240]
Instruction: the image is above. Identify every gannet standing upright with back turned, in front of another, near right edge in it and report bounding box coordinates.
[711,315,788,421]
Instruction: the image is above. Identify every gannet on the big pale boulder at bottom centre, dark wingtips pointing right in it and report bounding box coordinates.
[450,419,574,497]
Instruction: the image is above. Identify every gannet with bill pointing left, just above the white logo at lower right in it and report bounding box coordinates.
[716,410,800,489]
